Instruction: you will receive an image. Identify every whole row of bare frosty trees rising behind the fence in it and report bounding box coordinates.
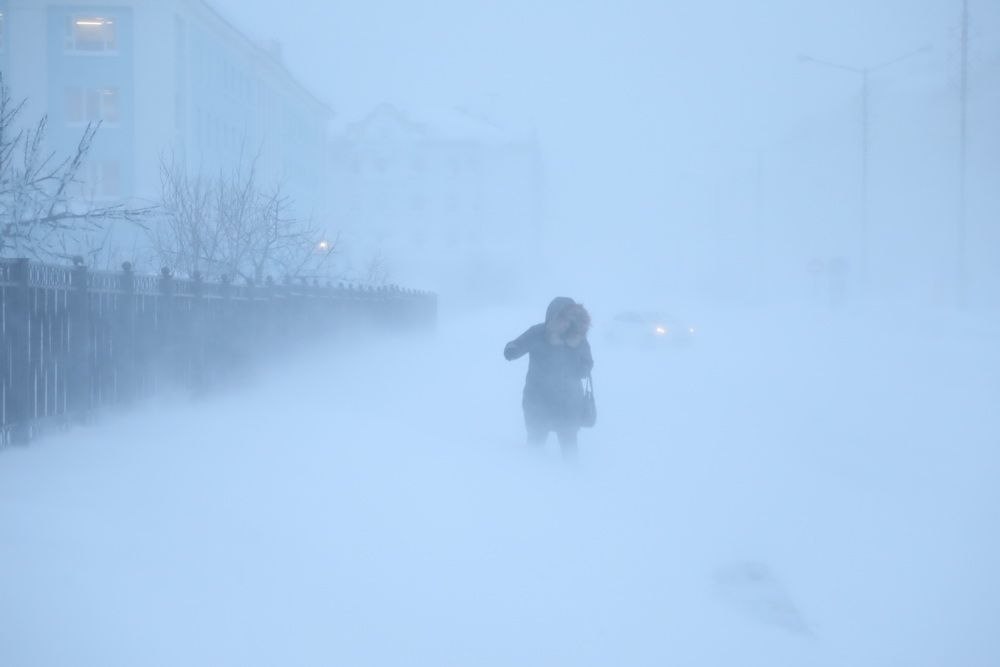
[0,74,364,285]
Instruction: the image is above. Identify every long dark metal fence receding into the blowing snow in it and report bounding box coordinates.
[0,259,437,446]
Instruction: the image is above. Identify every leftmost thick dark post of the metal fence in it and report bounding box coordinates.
[5,257,34,445]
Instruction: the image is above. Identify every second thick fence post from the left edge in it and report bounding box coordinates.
[66,257,95,421]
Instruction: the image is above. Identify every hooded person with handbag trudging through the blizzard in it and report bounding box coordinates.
[503,297,594,457]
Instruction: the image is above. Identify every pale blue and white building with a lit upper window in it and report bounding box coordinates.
[0,0,332,222]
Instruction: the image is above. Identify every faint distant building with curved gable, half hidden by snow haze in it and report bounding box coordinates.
[331,104,543,284]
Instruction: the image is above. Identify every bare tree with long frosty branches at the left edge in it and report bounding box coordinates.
[0,73,152,261]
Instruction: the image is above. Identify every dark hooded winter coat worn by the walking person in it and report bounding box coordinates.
[504,297,594,431]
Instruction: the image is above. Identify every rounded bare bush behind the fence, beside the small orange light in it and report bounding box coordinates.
[151,145,337,282]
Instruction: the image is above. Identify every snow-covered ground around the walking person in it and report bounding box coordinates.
[0,303,1000,667]
